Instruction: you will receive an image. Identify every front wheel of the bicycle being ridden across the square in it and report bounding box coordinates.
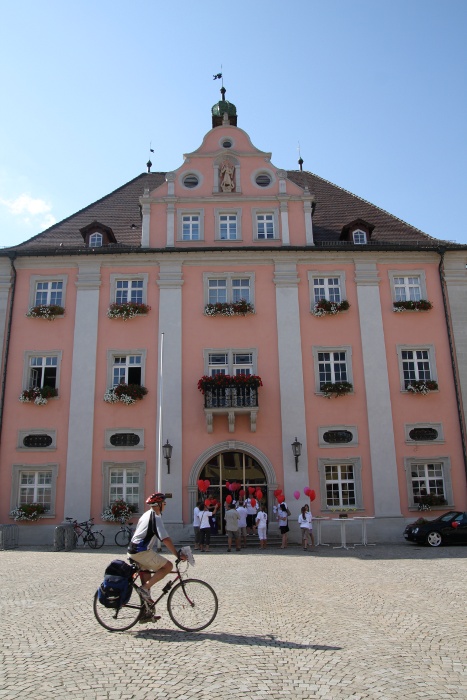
[167,578,219,632]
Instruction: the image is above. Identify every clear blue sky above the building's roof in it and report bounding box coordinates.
[0,0,467,246]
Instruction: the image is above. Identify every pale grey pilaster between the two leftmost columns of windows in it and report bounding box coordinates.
[64,260,101,520]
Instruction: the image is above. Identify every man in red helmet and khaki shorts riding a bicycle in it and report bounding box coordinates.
[128,493,186,602]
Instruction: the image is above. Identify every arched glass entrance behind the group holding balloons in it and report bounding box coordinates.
[189,440,277,532]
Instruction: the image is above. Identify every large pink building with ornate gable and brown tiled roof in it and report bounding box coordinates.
[0,95,467,544]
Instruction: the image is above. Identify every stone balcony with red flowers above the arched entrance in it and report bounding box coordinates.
[198,374,262,433]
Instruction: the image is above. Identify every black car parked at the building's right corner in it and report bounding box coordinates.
[404,510,467,547]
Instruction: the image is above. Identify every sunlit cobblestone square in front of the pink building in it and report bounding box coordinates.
[0,543,467,700]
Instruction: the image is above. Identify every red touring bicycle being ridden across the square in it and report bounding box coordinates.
[93,559,218,632]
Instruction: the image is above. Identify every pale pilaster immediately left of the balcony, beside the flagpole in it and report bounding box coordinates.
[157,262,183,524]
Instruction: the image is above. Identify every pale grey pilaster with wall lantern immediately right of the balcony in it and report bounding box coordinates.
[274,262,311,516]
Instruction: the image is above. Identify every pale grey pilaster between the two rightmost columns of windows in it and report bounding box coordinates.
[355,262,401,518]
